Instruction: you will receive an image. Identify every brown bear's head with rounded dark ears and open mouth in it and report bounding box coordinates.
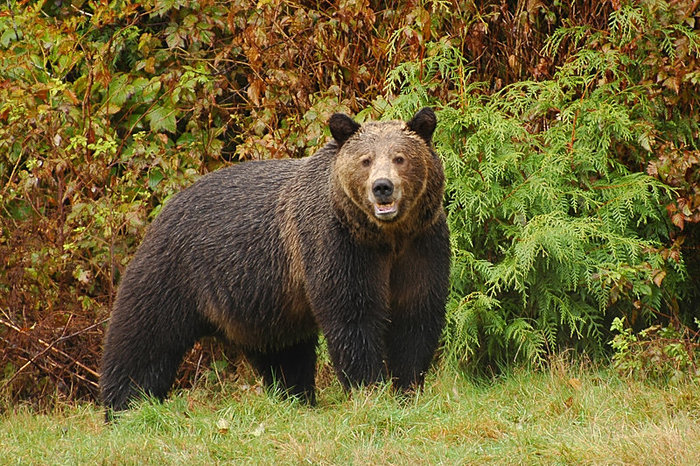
[329,108,444,238]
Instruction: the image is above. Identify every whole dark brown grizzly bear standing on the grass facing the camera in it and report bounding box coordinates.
[100,108,450,417]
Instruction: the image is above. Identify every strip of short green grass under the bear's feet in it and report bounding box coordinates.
[0,364,700,465]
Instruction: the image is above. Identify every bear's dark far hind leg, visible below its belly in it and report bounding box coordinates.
[246,335,318,406]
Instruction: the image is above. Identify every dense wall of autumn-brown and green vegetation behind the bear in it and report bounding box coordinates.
[0,0,700,402]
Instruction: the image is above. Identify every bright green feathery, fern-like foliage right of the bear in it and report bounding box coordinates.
[386,20,683,368]
